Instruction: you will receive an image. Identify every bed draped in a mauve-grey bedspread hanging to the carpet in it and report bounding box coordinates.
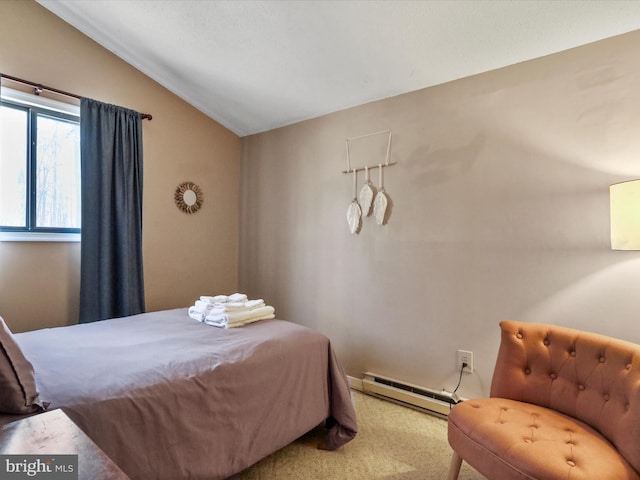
[0,309,357,480]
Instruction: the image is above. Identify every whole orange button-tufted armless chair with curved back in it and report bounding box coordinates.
[448,321,640,480]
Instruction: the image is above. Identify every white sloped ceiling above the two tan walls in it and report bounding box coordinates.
[37,0,640,136]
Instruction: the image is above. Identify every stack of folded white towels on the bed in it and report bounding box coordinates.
[189,293,275,328]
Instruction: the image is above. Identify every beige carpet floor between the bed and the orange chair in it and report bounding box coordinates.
[233,391,484,480]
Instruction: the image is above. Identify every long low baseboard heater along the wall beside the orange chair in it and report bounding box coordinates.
[362,372,457,417]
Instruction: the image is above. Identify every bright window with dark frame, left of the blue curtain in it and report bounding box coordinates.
[0,88,80,241]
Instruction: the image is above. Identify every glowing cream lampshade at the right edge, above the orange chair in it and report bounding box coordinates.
[609,180,640,250]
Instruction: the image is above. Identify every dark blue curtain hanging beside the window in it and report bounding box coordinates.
[80,98,145,323]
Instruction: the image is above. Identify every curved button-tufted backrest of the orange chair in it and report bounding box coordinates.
[491,320,640,471]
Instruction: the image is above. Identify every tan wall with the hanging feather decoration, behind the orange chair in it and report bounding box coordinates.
[240,28,640,396]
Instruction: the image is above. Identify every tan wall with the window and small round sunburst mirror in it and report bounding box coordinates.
[0,0,241,331]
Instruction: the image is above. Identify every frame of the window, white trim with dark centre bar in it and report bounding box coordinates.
[0,87,82,242]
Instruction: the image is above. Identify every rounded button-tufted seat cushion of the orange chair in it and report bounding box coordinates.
[448,398,640,480]
